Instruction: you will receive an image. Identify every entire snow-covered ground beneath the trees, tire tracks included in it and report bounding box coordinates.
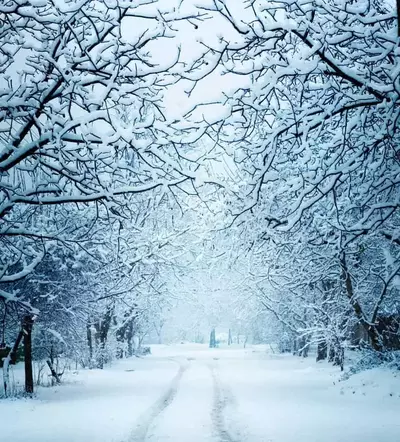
[0,345,400,442]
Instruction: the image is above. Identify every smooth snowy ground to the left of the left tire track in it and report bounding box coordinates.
[0,358,179,442]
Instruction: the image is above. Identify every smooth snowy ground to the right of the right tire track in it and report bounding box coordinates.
[219,355,400,442]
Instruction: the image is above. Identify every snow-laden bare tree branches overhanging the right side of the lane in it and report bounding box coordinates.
[187,0,400,360]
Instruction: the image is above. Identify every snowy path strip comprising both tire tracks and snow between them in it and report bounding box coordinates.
[129,353,236,442]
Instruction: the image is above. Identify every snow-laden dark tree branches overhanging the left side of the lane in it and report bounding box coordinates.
[0,0,209,299]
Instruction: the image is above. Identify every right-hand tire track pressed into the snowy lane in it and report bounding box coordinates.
[209,365,239,442]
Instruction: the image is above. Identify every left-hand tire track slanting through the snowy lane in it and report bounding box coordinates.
[128,360,189,442]
